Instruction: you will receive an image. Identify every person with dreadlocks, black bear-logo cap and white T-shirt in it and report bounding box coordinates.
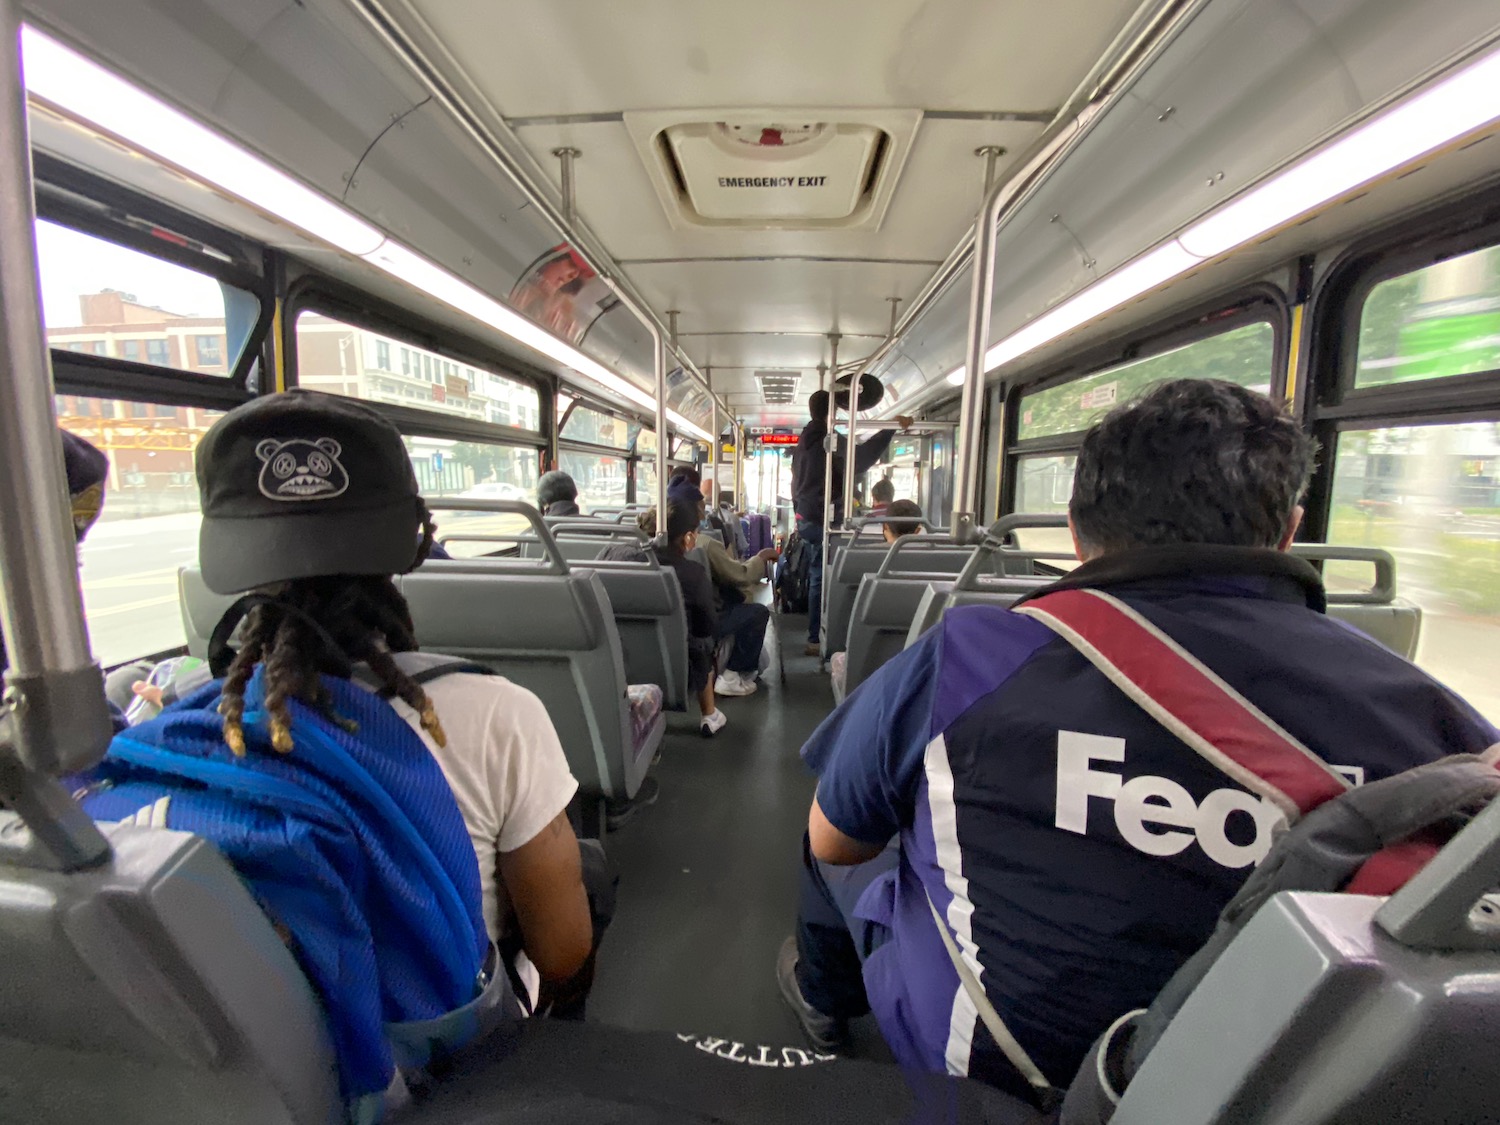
[96,390,596,1032]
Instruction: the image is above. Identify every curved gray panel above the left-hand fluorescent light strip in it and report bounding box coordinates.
[33,0,672,420]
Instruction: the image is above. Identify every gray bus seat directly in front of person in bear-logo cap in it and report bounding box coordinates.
[179,501,666,822]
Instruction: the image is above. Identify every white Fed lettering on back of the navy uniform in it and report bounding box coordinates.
[1055,731,1286,869]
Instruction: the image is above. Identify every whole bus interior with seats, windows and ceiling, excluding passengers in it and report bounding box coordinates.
[0,0,1500,1125]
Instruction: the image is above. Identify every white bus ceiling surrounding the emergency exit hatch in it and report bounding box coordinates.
[405,0,1136,420]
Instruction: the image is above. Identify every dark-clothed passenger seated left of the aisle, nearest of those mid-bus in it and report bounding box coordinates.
[600,498,729,744]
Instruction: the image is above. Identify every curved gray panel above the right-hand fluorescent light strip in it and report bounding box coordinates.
[879,0,1500,402]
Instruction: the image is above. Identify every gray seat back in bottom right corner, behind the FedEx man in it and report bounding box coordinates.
[1110,803,1500,1125]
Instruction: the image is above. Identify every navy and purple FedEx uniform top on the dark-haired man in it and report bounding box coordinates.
[803,548,1497,1092]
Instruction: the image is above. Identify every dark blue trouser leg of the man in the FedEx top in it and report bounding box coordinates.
[797,833,902,1020]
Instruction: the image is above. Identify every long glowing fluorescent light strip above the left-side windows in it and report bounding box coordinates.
[21,27,708,441]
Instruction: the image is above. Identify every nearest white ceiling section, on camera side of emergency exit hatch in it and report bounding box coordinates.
[417,0,1133,117]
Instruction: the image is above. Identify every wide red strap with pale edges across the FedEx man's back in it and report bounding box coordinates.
[1013,590,1350,824]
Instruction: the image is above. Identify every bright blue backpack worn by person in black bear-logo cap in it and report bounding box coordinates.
[83,654,506,1116]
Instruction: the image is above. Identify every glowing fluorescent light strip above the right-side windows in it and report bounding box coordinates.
[944,38,1500,387]
